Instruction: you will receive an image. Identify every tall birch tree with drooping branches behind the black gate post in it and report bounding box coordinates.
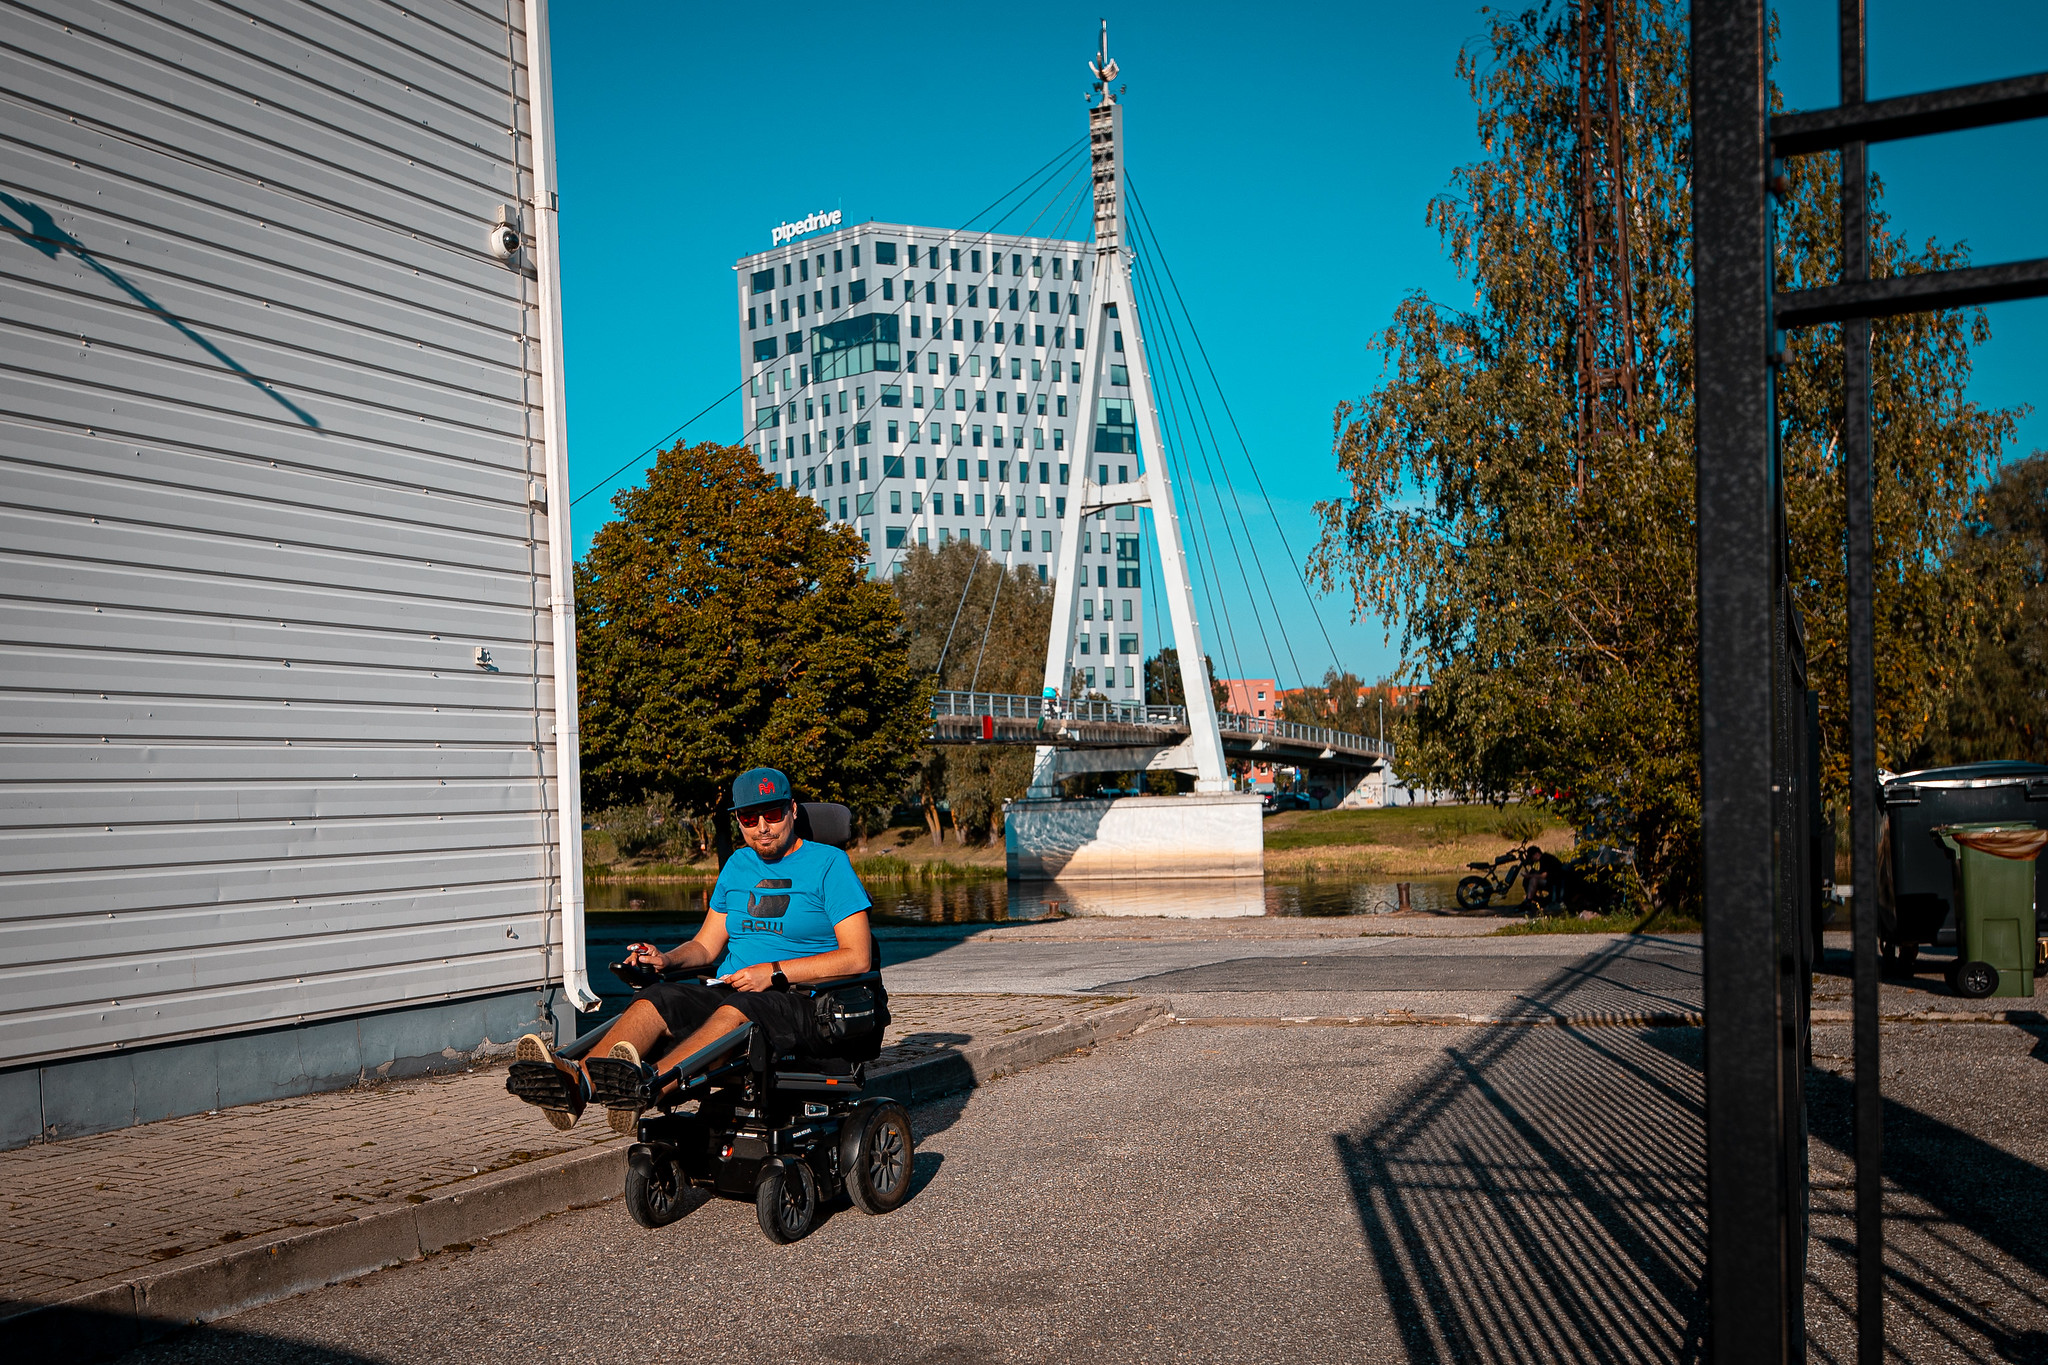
[1313,0,2011,905]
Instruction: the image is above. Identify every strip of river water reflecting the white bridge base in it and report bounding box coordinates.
[584,876,1482,925]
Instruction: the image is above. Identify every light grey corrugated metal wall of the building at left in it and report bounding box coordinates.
[0,0,561,1066]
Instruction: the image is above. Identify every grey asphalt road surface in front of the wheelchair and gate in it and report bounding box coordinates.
[127,939,2048,1365]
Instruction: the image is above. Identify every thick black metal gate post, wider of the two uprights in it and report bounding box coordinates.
[1692,0,1798,1365]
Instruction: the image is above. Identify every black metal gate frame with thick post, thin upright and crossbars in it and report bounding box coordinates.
[1692,0,2048,1365]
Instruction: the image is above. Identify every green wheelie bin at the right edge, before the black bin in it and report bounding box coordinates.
[1933,823,2048,999]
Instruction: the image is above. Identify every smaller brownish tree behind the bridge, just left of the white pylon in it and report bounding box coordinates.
[893,540,1053,843]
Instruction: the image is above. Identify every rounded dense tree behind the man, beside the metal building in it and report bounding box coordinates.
[575,442,930,843]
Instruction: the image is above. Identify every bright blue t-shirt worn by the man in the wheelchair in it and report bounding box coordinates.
[711,839,872,976]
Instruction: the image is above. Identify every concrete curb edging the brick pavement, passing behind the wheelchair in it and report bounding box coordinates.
[0,999,1165,1365]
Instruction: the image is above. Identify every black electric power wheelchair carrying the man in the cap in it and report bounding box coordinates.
[557,802,915,1242]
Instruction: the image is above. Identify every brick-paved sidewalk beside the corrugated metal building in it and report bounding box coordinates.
[0,995,1118,1302]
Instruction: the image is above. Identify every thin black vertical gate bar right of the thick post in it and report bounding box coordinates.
[1841,0,1884,1365]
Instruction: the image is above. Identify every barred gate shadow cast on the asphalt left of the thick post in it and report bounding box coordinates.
[1335,941,1706,1365]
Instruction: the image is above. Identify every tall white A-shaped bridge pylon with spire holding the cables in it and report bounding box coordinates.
[1028,20,1231,800]
